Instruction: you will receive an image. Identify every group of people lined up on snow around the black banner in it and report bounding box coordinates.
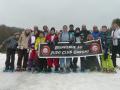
[0,19,120,73]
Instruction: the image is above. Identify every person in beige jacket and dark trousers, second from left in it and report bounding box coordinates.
[16,29,31,71]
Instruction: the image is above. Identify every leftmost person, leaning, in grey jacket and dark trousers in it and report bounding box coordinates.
[0,33,19,72]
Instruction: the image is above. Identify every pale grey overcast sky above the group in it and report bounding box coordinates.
[0,0,120,29]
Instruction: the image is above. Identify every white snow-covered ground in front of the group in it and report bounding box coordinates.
[0,54,120,90]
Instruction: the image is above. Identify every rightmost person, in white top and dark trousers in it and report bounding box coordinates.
[111,18,120,68]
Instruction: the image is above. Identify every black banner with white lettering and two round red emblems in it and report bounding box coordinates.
[39,40,102,58]
